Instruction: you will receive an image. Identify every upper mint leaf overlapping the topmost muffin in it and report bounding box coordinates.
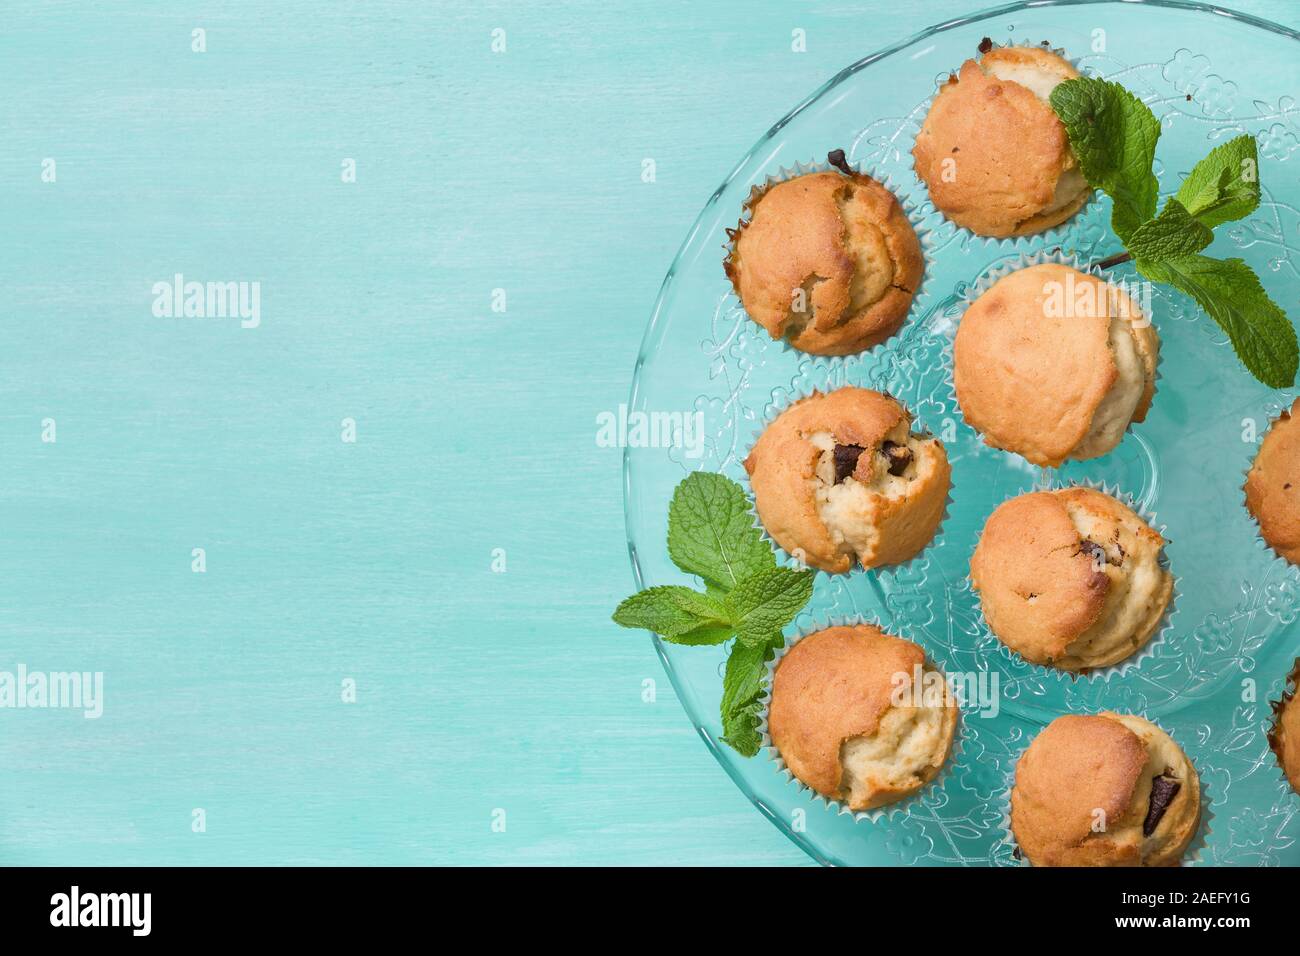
[1050,77,1160,245]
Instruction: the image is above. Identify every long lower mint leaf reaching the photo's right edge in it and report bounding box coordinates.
[1136,255,1300,389]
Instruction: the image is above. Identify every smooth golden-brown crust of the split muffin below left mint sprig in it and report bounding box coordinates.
[767,624,926,799]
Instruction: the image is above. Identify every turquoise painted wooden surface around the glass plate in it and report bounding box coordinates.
[0,0,1300,865]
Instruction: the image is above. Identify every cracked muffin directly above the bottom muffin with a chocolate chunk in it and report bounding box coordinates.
[971,488,1174,671]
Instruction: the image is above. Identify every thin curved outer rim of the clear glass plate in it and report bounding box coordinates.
[623,0,1300,866]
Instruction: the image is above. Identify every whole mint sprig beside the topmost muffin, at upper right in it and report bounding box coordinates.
[1052,77,1300,389]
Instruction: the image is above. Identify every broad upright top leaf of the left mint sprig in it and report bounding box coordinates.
[668,471,776,593]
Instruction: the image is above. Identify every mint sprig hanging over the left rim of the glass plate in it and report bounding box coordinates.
[614,471,813,757]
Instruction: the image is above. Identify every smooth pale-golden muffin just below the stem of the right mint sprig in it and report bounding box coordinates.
[953,263,1160,467]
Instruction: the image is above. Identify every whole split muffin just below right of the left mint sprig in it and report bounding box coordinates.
[767,624,957,810]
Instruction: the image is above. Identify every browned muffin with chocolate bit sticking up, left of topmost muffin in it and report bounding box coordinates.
[724,155,923,355]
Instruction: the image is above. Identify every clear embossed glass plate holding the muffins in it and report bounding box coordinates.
[624,3,1300,865]
